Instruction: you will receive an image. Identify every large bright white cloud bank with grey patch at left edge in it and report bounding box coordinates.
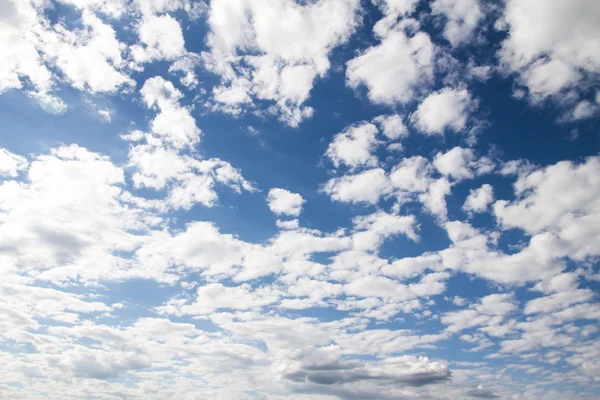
[0,145,160,282]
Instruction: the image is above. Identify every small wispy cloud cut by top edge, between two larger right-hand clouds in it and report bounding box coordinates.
[431,0,484,47]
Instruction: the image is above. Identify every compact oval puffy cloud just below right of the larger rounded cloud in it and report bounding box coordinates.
[411,88,478,135]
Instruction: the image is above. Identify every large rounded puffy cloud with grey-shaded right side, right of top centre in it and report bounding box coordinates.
[346,31,434,105]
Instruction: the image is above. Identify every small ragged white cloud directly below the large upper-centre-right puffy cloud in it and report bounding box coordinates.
[325,123,379,169]
